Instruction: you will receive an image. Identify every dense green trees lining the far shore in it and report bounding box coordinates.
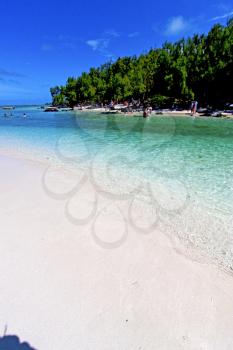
[51,18,233,107]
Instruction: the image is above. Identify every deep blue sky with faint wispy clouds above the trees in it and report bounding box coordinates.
[0,0,233,104]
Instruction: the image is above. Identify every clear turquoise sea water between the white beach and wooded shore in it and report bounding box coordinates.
[0,107,233,265]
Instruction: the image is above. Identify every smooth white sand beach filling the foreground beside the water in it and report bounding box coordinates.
[0,156,233,350]
